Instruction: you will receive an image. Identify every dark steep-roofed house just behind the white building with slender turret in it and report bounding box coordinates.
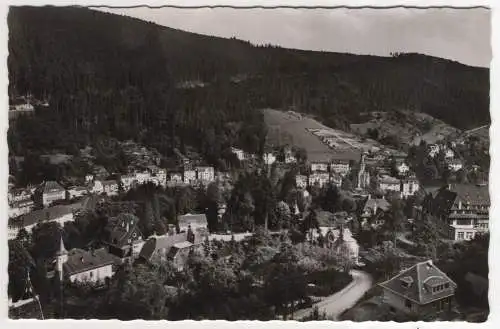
[106,213,144,259]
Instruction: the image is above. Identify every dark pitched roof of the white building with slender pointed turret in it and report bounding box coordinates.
[63,248,117,275]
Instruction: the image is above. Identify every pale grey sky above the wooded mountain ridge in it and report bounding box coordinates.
[95,8,492,67]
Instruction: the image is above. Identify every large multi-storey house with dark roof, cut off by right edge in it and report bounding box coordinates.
[427,184,490,241]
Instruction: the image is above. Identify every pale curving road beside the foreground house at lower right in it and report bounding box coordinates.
[294,270,373,320]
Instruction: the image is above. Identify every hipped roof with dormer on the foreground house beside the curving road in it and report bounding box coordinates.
[379,260,457,305]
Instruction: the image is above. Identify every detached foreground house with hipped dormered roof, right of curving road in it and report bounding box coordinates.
[379,260,457,316]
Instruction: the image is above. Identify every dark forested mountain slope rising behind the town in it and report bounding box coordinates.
[8,7,490,158]
